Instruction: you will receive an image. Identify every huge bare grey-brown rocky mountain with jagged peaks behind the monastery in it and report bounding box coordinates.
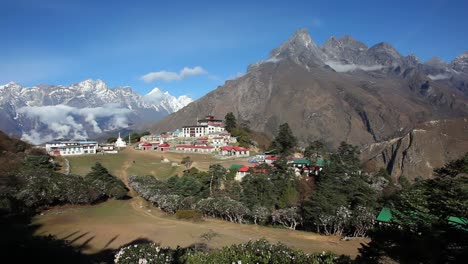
[153,30,468,146]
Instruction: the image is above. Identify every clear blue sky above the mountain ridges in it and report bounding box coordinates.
[0,0,468,98]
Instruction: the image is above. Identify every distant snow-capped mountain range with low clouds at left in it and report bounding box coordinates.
[0,80,192,144]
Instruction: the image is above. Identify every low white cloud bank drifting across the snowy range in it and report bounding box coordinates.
[18,104,131,144]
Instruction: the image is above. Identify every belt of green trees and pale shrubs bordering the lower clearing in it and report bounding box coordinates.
[129,136,388,236]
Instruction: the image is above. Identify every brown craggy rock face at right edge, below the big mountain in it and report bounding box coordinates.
[361,118,468,179]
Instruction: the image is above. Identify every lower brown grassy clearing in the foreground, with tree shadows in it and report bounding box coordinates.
[33,198,367,257]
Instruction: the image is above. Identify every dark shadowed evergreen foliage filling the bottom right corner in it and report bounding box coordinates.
[359,155,468,263]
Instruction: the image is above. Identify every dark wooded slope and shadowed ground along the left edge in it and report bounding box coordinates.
[0,131,127,263]
